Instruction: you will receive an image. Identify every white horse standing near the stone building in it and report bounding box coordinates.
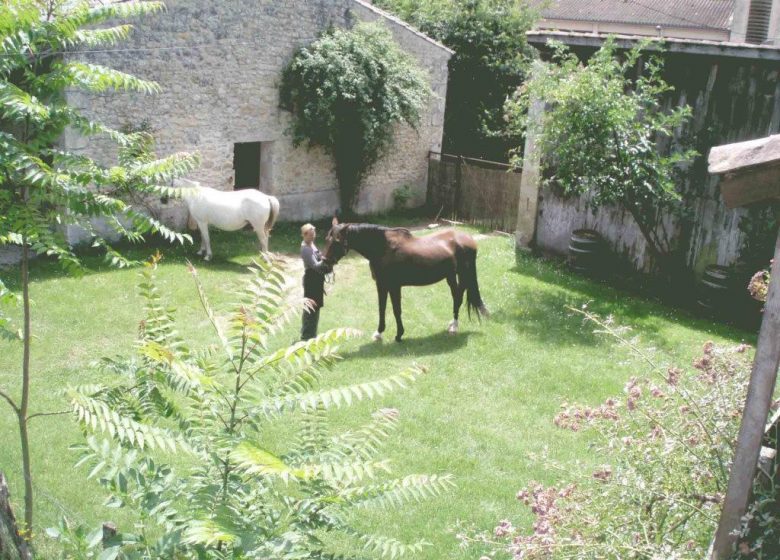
[178,179,279,261]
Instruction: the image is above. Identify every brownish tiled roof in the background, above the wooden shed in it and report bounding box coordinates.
[530,0,734,30]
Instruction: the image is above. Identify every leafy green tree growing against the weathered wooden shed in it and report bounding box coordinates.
[506,39,696,267]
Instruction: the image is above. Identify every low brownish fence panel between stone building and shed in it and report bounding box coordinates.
[427,152,521,232]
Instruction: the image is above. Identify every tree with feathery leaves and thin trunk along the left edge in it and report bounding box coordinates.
[0,0,196,534]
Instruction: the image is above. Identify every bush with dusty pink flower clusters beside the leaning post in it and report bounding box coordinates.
[462,310,770,560]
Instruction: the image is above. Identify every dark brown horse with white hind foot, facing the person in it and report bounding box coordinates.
[324,218,488,342]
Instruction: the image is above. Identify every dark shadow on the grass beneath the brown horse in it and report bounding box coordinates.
[344,330,483,360]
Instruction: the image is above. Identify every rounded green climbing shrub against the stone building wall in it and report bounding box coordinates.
[280,23,430,212]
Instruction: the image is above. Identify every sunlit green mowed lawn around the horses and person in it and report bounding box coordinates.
[0,220,754,559]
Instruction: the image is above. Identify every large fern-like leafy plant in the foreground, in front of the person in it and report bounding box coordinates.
[61,257,453,559]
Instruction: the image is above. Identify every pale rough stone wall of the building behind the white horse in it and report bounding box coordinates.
[64,0,452,227]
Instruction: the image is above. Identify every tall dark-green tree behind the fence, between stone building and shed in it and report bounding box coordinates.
[374,0,538,161]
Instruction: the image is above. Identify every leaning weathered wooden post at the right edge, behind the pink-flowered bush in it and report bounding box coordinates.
[711,230,780,560]
